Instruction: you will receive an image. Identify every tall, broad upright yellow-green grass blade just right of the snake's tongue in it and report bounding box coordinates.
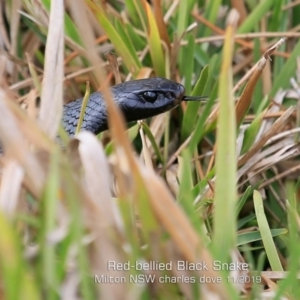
[213,14,237,262]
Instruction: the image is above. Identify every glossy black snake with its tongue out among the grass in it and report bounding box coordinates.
[62,77,200,135]
